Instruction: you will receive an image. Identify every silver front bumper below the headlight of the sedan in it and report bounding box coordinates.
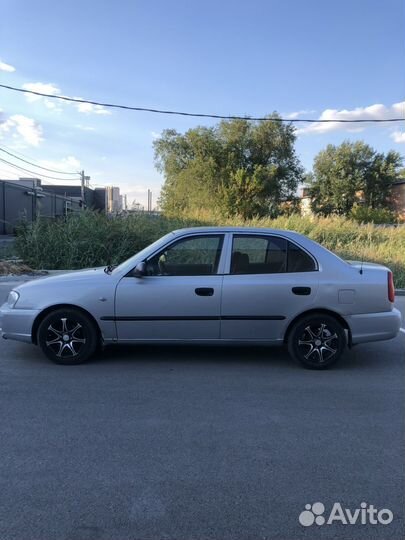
[0,303,40,343]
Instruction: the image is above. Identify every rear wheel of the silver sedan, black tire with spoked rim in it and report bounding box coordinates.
[288,313,347,369]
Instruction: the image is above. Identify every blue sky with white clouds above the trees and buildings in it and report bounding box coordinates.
[0,0,405,205]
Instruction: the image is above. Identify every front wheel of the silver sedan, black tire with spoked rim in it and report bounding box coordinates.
[37,308,99,366]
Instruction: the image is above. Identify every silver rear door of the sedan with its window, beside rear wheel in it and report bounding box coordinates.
[221,233,319,341]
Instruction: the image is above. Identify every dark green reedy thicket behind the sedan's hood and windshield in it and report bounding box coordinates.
[15,211,199,269]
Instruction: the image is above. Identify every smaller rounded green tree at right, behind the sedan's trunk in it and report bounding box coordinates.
[307,141,402,216]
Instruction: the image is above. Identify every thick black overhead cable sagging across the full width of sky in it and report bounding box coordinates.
[0,84,405,124]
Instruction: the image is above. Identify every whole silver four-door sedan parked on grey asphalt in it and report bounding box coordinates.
[0,227,401,369]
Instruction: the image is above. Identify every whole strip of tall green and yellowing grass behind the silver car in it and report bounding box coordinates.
[15,211,405,288]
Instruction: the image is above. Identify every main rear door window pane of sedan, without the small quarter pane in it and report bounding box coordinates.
[231,235,287,274]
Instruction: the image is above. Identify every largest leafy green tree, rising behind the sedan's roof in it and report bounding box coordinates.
[154,113,302,219]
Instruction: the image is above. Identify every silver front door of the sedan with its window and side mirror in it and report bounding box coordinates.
[115,234,225,341]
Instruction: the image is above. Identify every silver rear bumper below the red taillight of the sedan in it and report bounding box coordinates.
[345,308,402,345]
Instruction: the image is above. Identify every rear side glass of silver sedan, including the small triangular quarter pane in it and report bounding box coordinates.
[231,235,316,274]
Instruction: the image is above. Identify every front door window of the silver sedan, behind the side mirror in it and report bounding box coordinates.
[146,235,224,276]
